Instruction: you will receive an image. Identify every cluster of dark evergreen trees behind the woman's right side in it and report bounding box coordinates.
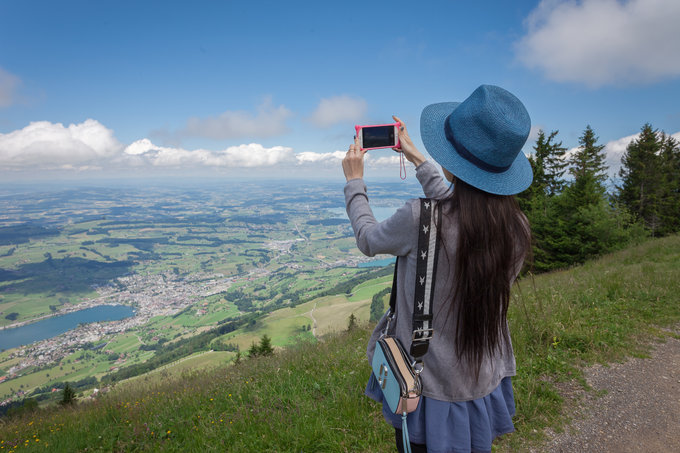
[518,124,680,271]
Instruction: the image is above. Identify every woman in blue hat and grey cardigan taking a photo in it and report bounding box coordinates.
[342,85,533,452]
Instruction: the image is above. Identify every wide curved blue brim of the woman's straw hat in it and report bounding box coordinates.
[420,102,533,195]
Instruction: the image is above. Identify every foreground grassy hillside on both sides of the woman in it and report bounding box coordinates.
[0,236,680,452]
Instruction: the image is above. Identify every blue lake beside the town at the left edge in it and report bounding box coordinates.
[0,305,135,350]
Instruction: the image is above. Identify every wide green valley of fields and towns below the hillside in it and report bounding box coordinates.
[0,183,408,402]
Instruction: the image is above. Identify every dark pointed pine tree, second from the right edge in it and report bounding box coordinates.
[618,123,665,236]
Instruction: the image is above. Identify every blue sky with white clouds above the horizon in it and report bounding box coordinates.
[0,0,680,182]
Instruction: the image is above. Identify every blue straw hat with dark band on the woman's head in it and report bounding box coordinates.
[420,85,533,195]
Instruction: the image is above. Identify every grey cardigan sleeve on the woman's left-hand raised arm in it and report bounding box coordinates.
[345,179,418,256]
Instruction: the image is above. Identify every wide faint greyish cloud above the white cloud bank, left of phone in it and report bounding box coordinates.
[182,98,293,140]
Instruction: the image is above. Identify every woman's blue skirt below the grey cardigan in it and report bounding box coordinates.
[366,373,515,453]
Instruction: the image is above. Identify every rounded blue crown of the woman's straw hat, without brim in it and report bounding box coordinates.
[445,85,531,171]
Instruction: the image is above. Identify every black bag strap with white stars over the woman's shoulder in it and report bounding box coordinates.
[390,198,442,362]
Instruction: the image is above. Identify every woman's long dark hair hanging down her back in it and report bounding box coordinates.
[440,179,531,378]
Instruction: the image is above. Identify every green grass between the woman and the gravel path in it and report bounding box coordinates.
[494,235,680,451]
